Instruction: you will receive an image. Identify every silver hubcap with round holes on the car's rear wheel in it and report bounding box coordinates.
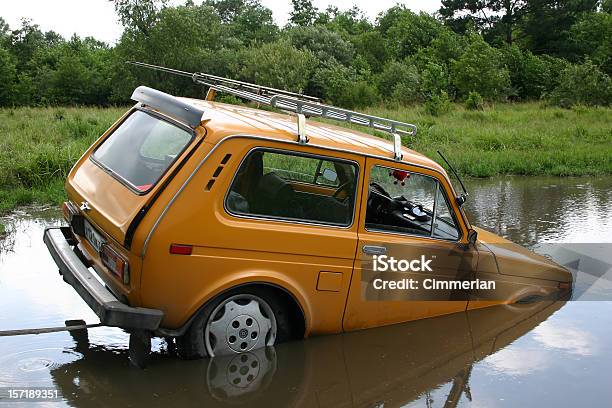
[204,294,276,357]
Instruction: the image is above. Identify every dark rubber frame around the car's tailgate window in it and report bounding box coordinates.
[89,106,196,196]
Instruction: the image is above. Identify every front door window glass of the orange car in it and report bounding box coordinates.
[365,166,459,239]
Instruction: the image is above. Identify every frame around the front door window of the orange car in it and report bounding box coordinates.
[362,163,463,243]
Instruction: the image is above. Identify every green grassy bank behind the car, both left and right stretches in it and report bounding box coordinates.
[0,103,612,213]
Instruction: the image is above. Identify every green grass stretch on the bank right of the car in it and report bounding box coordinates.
[334,103,612,177]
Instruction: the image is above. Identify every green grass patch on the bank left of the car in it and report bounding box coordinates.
[0,108,126,214]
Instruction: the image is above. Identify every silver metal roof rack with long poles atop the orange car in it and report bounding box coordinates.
[127,61,417,161]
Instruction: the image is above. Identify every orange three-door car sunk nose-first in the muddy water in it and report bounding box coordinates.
[44,67,572,358]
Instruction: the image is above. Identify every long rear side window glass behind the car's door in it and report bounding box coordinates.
[225,149,357,226]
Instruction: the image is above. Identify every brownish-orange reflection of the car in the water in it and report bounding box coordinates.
[51,301,565,407]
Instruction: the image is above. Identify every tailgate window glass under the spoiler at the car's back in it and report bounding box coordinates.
[93,111,193,193]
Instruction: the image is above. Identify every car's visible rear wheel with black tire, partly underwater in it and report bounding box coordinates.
[176,286,291,360]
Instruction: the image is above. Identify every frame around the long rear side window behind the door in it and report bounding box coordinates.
[223,146,361,230]
